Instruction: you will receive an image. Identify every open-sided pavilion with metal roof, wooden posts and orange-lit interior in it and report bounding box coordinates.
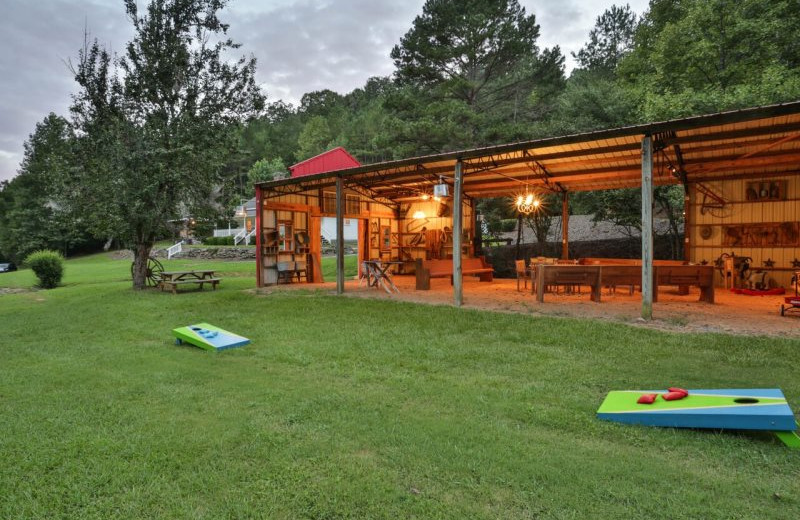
[256,101,800,318]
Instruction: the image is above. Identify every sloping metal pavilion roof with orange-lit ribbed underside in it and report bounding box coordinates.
[258,101,800,203]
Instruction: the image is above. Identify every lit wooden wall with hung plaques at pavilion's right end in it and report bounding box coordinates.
[687,174,800,288]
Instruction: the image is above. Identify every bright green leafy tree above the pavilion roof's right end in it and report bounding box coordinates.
[620,0,800,120]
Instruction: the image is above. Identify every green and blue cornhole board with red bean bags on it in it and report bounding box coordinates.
[597,388,800,449]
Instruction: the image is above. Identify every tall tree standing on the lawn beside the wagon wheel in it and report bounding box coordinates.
[62,0,264,289]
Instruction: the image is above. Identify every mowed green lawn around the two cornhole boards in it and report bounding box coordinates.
[0,255,800,519]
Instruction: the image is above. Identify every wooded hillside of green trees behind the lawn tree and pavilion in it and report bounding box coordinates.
[0,0,800,272]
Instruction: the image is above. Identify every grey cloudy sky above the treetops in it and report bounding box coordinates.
[0,0,647,180]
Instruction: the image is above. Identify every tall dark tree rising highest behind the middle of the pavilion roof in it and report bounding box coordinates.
[387,0,563,153]
